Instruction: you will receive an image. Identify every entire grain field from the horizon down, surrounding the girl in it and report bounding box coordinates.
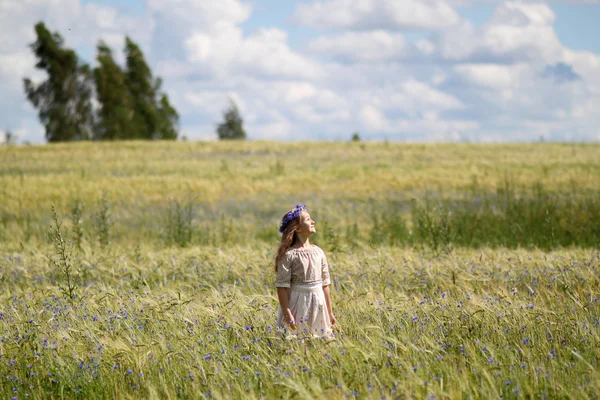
[0,142,600,399]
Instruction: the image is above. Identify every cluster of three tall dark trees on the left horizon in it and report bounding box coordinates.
[23,22,179,142]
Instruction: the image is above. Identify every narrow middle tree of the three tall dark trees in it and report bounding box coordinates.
[94,42,135,140]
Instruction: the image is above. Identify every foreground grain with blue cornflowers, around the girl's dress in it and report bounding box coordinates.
[0,247,600,399]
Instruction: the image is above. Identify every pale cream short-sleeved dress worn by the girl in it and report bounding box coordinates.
[275,245,332,337]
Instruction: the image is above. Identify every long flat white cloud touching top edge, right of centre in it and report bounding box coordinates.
[293,0,461,30]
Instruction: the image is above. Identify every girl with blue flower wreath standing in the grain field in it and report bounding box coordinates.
[275,204,335,337]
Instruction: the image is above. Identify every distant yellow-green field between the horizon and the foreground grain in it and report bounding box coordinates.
[0,142,600,250]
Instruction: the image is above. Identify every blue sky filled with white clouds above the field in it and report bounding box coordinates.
[0,0,600,143]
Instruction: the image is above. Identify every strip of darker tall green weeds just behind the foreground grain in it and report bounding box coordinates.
[5,183,600,250]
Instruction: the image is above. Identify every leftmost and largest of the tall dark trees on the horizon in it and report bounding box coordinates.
[23,22,93,142]
